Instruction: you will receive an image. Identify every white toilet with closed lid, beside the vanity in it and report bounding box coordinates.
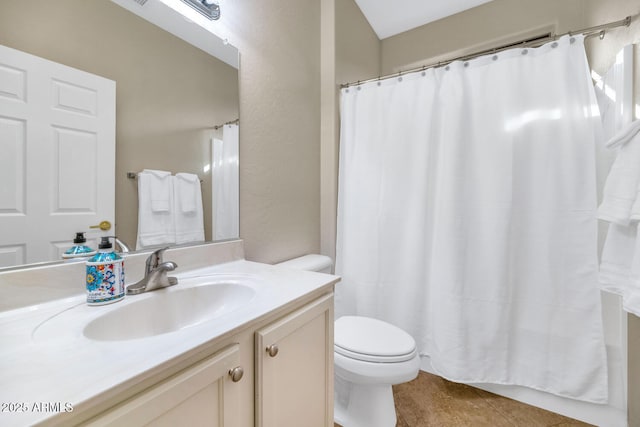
[278,254,420,427]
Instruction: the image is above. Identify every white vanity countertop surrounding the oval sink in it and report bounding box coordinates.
[0,260,338,426]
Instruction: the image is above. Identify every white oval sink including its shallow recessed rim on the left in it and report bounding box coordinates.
[31,275,264,342]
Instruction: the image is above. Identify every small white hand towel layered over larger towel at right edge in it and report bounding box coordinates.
[598,133,640,225]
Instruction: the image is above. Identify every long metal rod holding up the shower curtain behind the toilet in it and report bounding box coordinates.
[340,14,640,89]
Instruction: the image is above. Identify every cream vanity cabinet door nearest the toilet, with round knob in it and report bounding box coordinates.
[255,294,333,427]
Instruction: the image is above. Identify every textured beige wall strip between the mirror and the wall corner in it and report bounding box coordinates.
[222,0,320,263]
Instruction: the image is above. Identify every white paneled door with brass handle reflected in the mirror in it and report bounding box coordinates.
[0,46,115,267]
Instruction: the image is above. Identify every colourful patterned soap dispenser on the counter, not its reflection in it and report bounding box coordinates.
[86,237,124,305]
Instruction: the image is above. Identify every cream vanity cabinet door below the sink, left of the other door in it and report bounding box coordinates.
[87,344,242,427]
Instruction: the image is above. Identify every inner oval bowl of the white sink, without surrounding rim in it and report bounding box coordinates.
[83,282,255,341]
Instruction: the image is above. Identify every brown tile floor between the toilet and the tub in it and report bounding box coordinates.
[336,371,590,427]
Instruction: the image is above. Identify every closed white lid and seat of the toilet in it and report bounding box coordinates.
[334,316,417,363]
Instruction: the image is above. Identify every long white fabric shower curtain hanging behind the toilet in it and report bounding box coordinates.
[336,36,607,403]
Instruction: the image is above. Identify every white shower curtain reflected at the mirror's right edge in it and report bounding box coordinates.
[211,124,240,240]
